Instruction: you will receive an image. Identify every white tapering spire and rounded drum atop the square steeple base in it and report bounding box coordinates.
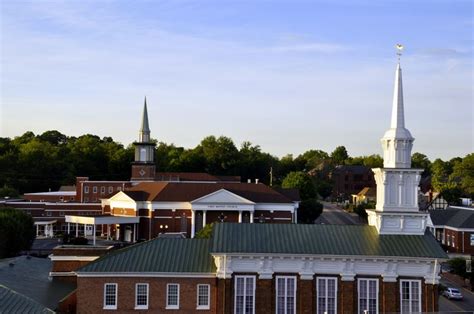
[381,60,414,168]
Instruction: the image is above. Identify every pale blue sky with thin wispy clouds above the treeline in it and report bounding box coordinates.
[0,0,474,160]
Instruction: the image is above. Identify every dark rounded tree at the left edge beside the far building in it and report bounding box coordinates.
[0,207,35,258]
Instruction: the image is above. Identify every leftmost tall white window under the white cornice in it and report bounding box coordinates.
[234,276,255,314]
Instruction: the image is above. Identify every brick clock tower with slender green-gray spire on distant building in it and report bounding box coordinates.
[131,97,156,181]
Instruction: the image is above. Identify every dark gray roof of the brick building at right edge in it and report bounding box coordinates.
[429,207,474,229]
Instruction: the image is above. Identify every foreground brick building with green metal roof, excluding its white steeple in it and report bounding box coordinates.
[77,223,446,313]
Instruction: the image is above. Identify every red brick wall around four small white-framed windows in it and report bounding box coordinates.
[77,277,217,313]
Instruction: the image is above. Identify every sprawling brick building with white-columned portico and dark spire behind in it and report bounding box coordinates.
[2,99,299,239]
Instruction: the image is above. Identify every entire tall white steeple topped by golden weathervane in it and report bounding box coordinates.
[367,45,427,234]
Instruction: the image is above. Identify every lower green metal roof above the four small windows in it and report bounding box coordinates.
[78,238,215,273]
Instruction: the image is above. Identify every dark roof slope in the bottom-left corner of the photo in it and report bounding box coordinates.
[0,285,54,314]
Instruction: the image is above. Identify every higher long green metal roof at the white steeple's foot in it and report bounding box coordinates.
[211,223,447,258]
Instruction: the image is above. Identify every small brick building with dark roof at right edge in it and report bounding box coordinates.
[428,206,474,255]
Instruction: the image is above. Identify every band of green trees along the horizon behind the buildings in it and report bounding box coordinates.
[0,131,474,204]
